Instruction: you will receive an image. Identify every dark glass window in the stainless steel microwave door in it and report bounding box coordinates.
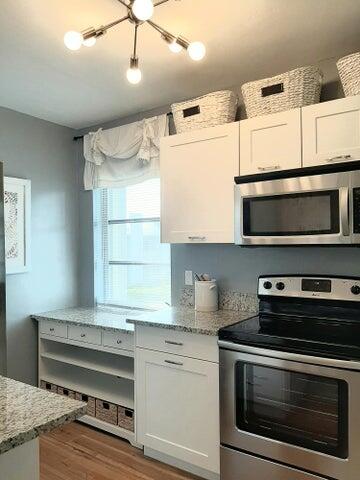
[243,190,340,236]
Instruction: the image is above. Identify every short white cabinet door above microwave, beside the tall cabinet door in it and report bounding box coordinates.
[240,108,301,175]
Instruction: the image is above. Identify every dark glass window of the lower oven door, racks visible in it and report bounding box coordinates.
[235,362,348,458]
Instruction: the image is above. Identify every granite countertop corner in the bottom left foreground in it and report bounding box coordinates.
[0,376,86,461]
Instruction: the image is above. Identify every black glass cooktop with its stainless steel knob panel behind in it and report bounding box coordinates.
[219,275,360,360]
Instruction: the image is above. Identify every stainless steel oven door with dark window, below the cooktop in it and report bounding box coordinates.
[220,342,360,480]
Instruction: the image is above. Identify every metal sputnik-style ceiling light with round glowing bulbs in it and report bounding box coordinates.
[64,0,206,84]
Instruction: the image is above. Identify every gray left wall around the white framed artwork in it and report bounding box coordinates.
[0,108,79,384]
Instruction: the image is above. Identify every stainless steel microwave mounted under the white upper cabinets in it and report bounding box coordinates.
[235,162,360,245]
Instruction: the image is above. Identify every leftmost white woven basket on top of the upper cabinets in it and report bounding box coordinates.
[171,90,238,133]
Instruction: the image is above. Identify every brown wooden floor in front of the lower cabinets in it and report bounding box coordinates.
[40,423,201,480]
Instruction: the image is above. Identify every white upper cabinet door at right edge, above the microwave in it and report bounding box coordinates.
[302,96,360,167]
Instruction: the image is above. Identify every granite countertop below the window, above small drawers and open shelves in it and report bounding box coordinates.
[32,307,143,334]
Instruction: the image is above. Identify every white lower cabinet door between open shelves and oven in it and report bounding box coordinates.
[136,348,220,473]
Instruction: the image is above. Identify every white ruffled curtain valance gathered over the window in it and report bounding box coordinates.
[84,115,169,190]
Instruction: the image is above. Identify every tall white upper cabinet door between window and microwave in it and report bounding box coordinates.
[160,122,239,243]
